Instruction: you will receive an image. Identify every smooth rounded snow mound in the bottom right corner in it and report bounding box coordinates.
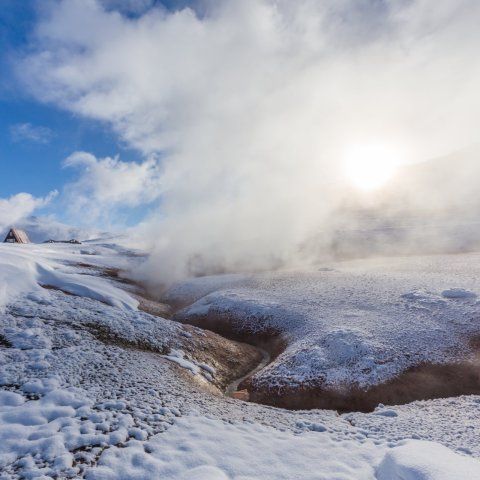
[377,441,480,480]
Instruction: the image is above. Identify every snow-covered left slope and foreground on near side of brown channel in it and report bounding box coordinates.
[0,243,480,480]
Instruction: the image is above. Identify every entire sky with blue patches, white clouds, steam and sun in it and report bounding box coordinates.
[0,0,480,278]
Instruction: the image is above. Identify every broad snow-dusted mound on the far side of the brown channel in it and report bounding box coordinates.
[170,253,480,388]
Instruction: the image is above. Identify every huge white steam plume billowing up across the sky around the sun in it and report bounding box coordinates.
[17,0,480,285]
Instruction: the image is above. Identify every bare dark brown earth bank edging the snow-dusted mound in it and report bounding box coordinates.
[173,311,480,412]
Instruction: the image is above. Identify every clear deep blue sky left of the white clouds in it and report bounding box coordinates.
[0,0,187,223]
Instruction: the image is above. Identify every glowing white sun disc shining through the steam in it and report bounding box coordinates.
[344,145,399,191]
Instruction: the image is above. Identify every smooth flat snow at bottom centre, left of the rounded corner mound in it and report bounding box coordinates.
[87,417,382,480]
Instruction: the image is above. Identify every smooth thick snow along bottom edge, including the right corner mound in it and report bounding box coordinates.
[87,417,480,480]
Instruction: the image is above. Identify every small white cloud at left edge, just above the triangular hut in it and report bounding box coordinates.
[0,191,57,230]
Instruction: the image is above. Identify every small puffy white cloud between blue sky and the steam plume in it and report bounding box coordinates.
[63,152,161,223]
